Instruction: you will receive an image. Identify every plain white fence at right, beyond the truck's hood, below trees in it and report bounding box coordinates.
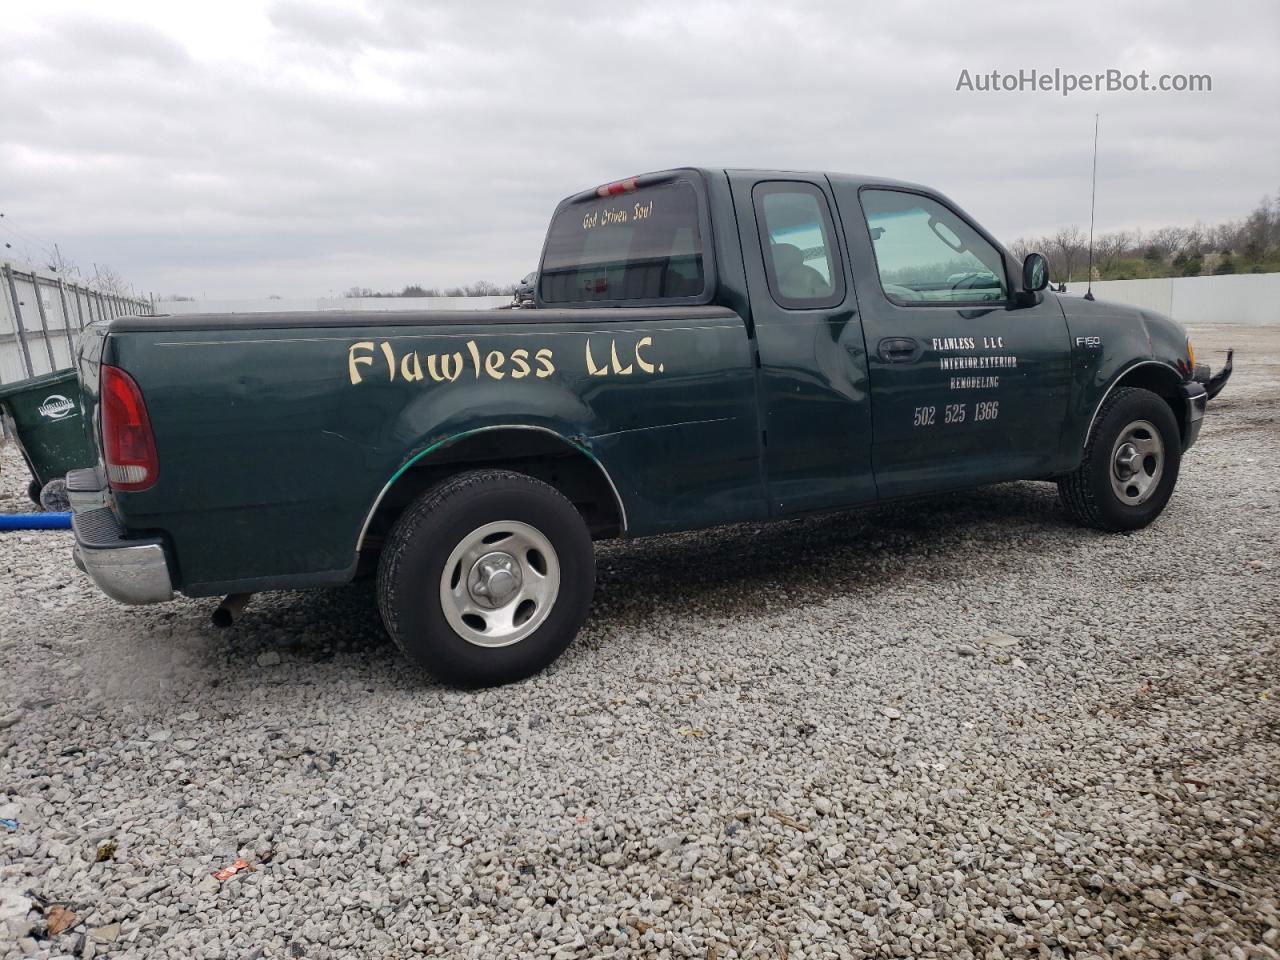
[1068,274,1280,326]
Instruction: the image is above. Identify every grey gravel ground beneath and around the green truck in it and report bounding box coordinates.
[0,328,1280,960]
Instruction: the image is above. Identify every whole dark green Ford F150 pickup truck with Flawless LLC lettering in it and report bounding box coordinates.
[68,169,1230,685]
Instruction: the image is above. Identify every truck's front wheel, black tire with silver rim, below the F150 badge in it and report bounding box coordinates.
[1057,387,1183,531]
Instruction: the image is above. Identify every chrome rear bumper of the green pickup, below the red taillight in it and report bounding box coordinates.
[72,491,173,604]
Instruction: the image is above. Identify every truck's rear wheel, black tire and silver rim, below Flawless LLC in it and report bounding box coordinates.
[378,470,595,686]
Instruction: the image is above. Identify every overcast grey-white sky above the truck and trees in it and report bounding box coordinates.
[0,0,1280,298]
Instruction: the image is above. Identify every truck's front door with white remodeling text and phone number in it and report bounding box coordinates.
[836,184,1070,498]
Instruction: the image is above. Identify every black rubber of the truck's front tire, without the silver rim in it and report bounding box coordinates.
[1057,387,1183,531]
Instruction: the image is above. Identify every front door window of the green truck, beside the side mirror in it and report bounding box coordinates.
[859,189,1009,306]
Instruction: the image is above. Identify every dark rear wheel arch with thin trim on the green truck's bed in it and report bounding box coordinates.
[356,424,627,558]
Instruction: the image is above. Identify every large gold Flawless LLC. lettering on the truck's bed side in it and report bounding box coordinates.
[347,337,664,385]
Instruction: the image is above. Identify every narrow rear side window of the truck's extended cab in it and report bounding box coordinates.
[751,180,845,310]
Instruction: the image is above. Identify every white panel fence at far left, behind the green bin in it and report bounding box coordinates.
[0,262,151,384]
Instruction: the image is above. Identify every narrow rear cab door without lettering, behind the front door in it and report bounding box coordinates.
[730,173,876,516]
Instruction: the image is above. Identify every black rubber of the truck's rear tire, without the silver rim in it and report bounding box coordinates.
[378,470,595,687]
